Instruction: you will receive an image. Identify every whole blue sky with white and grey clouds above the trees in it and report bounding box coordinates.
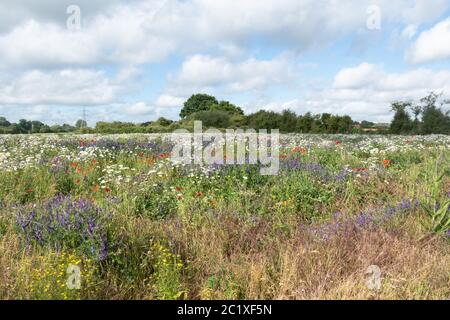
[0,0,450,125]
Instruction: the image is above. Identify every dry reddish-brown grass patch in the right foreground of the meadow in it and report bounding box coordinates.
[159,211,450,299]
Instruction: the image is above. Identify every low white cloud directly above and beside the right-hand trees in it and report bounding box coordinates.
[302,63,450,121]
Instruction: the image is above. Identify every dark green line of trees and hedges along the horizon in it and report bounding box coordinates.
[0,93,450,134]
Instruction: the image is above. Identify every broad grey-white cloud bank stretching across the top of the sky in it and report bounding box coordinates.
[0,0,450,68]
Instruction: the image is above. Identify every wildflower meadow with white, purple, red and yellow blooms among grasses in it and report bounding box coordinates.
[0,134,450,299]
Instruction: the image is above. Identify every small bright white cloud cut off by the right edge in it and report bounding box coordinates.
[407,18,450,63]
